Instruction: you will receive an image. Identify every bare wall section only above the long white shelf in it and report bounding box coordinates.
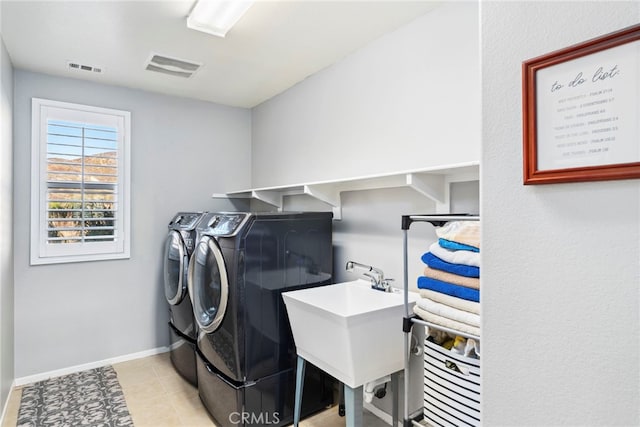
[250,2,480,189]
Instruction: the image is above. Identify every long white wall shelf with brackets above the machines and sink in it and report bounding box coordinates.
[212,162,480,219]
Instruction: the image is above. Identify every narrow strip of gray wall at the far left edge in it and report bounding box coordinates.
[0,38,14,413]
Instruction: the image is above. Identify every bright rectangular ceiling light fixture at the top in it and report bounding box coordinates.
[187,0,253,37]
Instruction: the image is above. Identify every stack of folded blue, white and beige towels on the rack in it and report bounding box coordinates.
[413,221,480,336]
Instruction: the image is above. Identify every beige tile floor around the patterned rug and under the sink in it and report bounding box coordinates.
[2,353,387,427]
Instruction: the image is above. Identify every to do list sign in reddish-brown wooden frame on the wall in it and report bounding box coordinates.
[522,24,640,184]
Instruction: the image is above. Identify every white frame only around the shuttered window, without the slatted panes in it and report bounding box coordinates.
[30,98,131,265]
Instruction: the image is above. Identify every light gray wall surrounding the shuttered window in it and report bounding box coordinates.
[14,70,251,378]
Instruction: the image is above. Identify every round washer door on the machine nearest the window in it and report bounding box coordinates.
[164,230,188,305]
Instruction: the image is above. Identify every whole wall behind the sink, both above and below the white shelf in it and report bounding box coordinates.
[252,2,480,422]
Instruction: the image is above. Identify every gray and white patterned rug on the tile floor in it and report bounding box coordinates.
[17,366,133,427]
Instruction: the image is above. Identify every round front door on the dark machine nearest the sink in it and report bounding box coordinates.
[189,236,229,333]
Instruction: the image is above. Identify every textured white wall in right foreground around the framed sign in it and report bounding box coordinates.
[481,1,640,426]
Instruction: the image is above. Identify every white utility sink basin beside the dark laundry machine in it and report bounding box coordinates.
[282,279,418,388]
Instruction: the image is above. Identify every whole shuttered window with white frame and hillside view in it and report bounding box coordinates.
[31,98,130,264]
